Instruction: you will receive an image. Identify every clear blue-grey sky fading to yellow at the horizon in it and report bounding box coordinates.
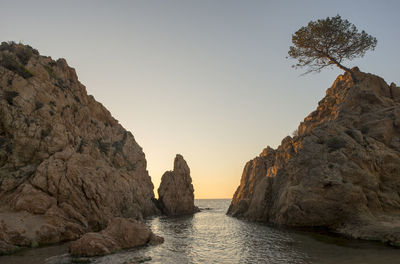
[0,0,400,198]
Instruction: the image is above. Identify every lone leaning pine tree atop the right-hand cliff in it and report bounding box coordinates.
[288,15,377,80]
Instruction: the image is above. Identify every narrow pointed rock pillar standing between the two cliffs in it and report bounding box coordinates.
[158,154,199,215]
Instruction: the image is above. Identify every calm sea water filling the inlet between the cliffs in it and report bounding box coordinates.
[0,200,400,264]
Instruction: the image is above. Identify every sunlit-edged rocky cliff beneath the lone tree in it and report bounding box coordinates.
[228,68,400,246]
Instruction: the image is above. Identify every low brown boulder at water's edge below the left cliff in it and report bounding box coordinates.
[69,218,164,257]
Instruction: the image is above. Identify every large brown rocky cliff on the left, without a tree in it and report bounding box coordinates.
[0,43,158,252]
